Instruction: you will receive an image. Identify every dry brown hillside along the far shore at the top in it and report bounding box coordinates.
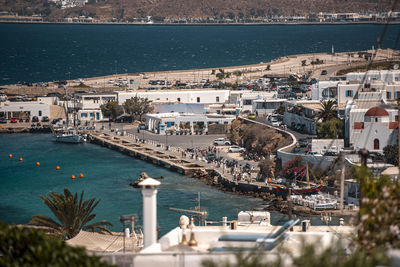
[0,0,391,20]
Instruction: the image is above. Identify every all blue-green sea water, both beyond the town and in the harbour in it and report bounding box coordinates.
[0,24,400,234]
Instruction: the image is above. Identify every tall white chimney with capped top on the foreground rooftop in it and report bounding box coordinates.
[139,178,160,248]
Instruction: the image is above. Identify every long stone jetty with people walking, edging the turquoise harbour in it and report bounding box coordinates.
[88,130,353,218]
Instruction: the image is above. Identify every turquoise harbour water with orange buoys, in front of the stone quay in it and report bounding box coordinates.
[0,134,270,233]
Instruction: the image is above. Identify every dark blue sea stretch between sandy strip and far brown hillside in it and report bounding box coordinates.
[0,24,400,85]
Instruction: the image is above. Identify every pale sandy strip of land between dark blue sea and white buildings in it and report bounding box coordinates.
[2,49,399,96]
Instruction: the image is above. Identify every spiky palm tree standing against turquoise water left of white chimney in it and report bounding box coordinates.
[29,188,112,239]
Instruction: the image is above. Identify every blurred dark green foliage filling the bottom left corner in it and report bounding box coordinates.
[0,223,111,267]
